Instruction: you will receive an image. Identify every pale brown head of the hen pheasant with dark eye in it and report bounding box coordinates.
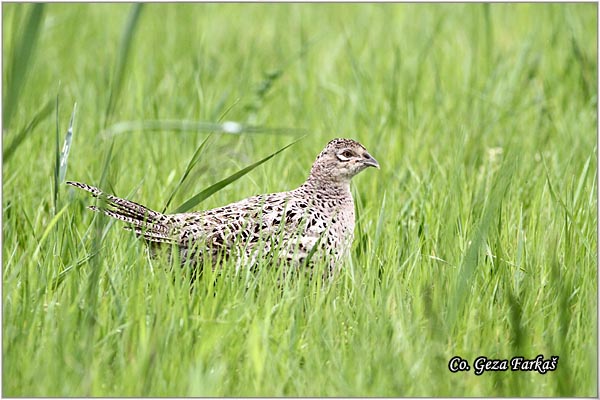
[309,139,379,184]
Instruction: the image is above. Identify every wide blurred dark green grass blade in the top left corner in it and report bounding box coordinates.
[2,3,44,130]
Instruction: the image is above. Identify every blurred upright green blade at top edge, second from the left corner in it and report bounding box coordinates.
[104,3,143,124]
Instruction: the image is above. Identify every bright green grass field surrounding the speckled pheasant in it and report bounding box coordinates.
[2,4,598,397]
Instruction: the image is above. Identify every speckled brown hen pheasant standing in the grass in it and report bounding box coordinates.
[66,138,380,276]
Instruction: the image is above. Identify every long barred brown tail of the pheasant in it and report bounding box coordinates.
[67,181,174,243]
